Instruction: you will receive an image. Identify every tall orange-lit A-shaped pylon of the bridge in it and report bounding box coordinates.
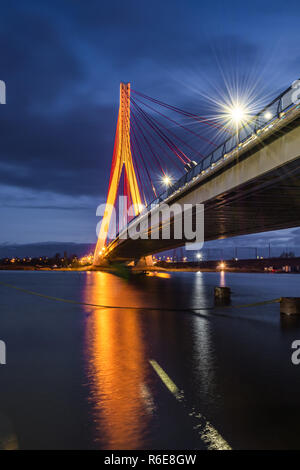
[94,83,142,265]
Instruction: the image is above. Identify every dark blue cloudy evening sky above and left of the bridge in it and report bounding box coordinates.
[0,0,300,248]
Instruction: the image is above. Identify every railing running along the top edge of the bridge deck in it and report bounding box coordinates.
[117,82,300,241]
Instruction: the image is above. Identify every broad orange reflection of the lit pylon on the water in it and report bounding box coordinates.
[84,272,151,449]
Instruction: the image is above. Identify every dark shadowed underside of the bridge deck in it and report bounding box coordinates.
[105,157,300,261]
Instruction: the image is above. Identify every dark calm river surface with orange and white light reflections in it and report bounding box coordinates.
[0,271,300,449]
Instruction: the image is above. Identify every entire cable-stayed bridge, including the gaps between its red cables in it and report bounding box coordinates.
[94,83,300,265]
